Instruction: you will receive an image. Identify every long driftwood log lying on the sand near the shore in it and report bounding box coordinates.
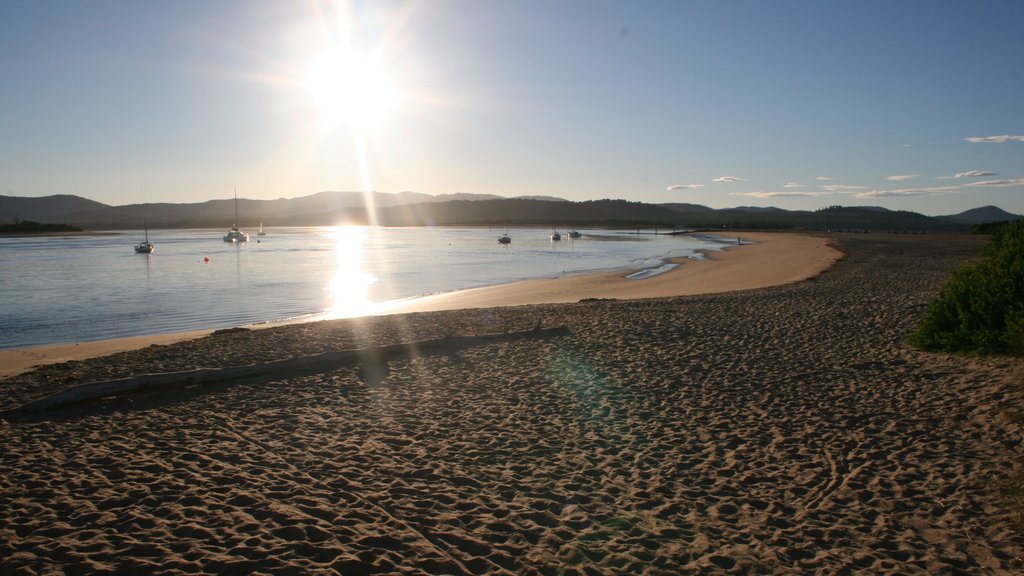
[13,324,569,414]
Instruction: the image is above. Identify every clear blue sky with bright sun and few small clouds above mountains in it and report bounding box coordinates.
[0,0,1024,215]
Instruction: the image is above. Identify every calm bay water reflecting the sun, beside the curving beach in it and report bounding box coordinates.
[0,228,737,348]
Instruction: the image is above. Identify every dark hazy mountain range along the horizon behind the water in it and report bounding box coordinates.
[0,192,1021,232]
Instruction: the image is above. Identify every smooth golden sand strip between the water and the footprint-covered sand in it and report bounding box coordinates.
[0,232,842,380]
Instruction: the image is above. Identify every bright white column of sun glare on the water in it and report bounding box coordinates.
[326,227,377,319]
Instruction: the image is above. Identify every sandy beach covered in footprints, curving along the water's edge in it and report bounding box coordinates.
[0,230,1024,575]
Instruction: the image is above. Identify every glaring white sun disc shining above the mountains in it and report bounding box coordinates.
[305,46,397,137]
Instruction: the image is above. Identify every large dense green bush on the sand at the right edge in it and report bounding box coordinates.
[910,220,1024,355]
